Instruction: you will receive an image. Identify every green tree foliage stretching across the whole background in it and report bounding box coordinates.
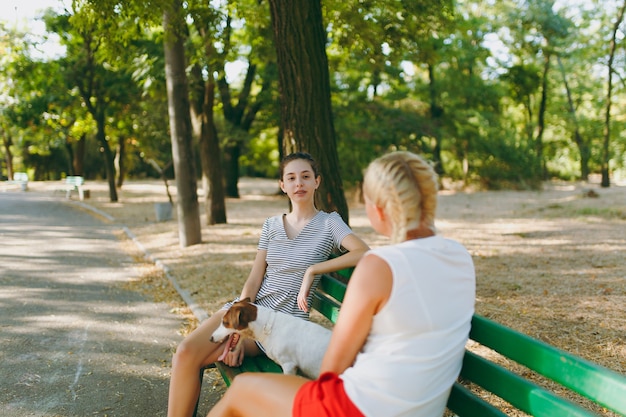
[0,0,626,188]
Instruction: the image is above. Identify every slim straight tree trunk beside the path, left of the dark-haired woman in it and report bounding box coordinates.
[163,0,202,248]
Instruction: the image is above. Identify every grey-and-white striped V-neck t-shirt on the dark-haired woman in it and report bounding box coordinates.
[255,211,352,319]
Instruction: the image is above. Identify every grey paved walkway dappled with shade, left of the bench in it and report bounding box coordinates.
[0,192,181,417]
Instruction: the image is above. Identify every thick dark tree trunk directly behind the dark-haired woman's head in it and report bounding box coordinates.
[269,0,349,223]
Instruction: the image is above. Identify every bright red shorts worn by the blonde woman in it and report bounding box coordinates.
[292,372,364,417]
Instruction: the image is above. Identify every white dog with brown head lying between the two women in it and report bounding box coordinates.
[211,299,331,379]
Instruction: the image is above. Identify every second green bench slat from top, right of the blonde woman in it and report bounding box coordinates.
[461,351,595,417]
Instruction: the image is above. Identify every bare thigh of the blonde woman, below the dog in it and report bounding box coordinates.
[207,373,309,417]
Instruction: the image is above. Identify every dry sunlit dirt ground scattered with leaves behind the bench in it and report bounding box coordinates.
[22,178,626,415]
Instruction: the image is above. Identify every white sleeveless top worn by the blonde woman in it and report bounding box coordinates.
[341,236,475,417]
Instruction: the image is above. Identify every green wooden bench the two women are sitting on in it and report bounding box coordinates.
[196,270,626,417]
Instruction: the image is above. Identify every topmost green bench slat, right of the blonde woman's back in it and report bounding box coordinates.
[470,315,626,415]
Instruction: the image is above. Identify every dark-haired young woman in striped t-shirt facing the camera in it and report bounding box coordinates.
[168,152,369,417]
